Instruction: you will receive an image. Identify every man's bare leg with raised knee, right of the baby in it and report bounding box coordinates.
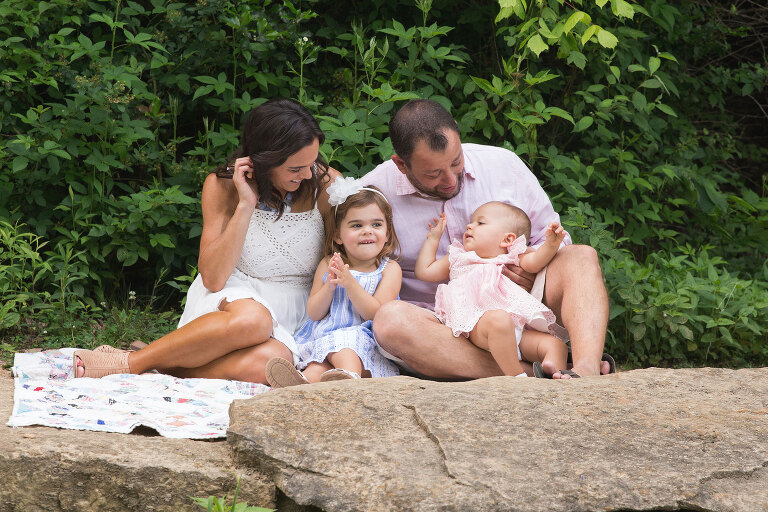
[543,245,609,379]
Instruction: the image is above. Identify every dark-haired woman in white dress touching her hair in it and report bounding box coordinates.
[74,99,340,383]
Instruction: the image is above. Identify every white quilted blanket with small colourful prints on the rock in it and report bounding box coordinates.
[8,348,270,439]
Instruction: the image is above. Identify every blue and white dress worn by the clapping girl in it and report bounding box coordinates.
[294,258,400,377]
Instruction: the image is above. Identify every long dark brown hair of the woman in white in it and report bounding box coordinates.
[216,98,328,219]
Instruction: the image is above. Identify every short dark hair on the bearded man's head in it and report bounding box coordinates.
[389,100,459,162]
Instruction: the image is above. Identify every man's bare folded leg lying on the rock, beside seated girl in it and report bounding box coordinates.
[373,300,503,379]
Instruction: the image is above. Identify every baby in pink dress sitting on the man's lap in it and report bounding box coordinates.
[415,201,568,377]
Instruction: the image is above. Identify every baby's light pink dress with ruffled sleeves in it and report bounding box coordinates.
[435,236,564,337]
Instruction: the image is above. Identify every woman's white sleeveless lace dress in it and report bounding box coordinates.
[179,208,324,364]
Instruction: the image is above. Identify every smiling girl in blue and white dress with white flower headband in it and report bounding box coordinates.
[266,178,402,388]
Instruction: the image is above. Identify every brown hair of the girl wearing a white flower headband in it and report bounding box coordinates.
[323,185,400,266]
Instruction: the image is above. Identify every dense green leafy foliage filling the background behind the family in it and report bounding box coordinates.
[0,0,768,365]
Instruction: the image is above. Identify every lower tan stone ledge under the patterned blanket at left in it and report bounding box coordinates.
[0,370,275,512]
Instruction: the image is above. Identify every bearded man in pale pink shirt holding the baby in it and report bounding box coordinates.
[362,100,611,379]
